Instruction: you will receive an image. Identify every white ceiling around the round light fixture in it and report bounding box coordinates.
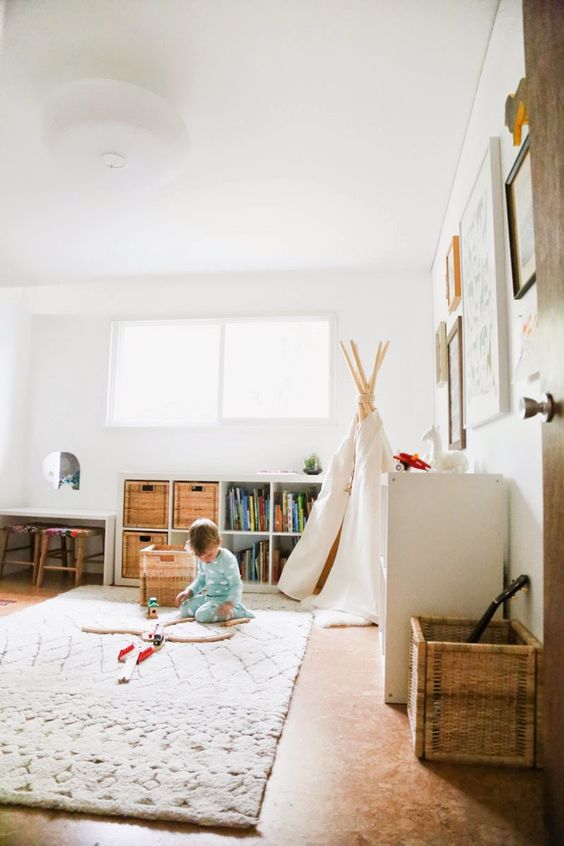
[0,0,498,285]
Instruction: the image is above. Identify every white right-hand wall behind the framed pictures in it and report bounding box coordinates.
[432,0,543,639]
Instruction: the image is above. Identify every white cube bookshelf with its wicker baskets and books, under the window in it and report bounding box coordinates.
[115,473,322,592]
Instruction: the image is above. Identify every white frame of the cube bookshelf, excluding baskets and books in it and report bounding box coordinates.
[114,472,323,593]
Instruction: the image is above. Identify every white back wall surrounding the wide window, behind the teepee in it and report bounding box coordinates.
[14,272,433,508]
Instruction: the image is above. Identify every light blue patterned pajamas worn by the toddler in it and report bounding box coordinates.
[180,548,255,623]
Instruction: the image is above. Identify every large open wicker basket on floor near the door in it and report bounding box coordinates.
[407,617,542,767]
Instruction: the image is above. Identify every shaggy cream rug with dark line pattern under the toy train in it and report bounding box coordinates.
[0,586,311,827]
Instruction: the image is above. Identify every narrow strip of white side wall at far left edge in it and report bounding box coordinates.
[0,289,31,506]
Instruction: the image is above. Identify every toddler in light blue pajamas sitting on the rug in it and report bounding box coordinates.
[175,518,255,623]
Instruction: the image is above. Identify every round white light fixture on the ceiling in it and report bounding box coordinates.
[43,79,188,190]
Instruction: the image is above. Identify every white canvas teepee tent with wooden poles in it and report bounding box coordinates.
[278,341,394,623]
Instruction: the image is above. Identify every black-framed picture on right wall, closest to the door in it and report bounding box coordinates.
[505,136,537,300]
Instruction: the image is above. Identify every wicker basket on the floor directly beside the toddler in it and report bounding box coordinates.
[139,545,196,606]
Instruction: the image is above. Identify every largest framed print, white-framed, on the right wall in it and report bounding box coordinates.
[460,138,509,428]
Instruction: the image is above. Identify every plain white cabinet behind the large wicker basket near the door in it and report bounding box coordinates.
[379,472,505,702]
